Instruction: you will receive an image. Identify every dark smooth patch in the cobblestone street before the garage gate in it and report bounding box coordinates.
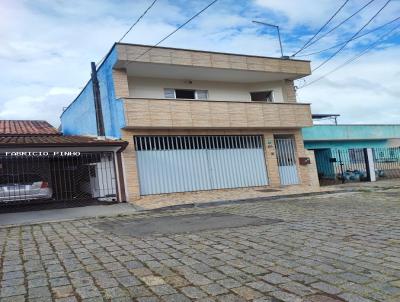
[93,213,283,236]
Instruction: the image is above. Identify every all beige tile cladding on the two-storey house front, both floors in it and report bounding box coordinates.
[113,44,319,205]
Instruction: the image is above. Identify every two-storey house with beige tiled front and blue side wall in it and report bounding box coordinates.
[61,43,316,200]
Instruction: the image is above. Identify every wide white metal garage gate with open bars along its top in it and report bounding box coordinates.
[134,135,268,195]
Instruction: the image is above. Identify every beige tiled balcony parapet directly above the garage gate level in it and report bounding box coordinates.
[123,98,312,129]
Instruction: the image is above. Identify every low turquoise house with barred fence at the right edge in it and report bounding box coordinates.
[302,124,400,180]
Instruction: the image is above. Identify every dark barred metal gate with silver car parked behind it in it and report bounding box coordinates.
[0,152,117,205]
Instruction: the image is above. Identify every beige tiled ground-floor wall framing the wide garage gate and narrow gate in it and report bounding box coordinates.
[122,129,319,201]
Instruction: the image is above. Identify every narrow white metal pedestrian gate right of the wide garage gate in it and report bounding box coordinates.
[275,136,299,185]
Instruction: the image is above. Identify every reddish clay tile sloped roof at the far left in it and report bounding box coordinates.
[0,120,61,136]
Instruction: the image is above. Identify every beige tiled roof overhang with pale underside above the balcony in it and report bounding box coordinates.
[114,43,311,82]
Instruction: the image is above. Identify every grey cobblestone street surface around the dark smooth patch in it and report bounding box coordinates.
[0,185,400,302]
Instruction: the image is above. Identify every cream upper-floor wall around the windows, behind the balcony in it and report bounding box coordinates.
[128,77,287,102]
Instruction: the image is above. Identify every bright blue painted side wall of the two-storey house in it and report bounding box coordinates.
[61,47,125,138]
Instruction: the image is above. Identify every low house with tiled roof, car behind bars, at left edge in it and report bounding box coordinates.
[0,120,126,205]
